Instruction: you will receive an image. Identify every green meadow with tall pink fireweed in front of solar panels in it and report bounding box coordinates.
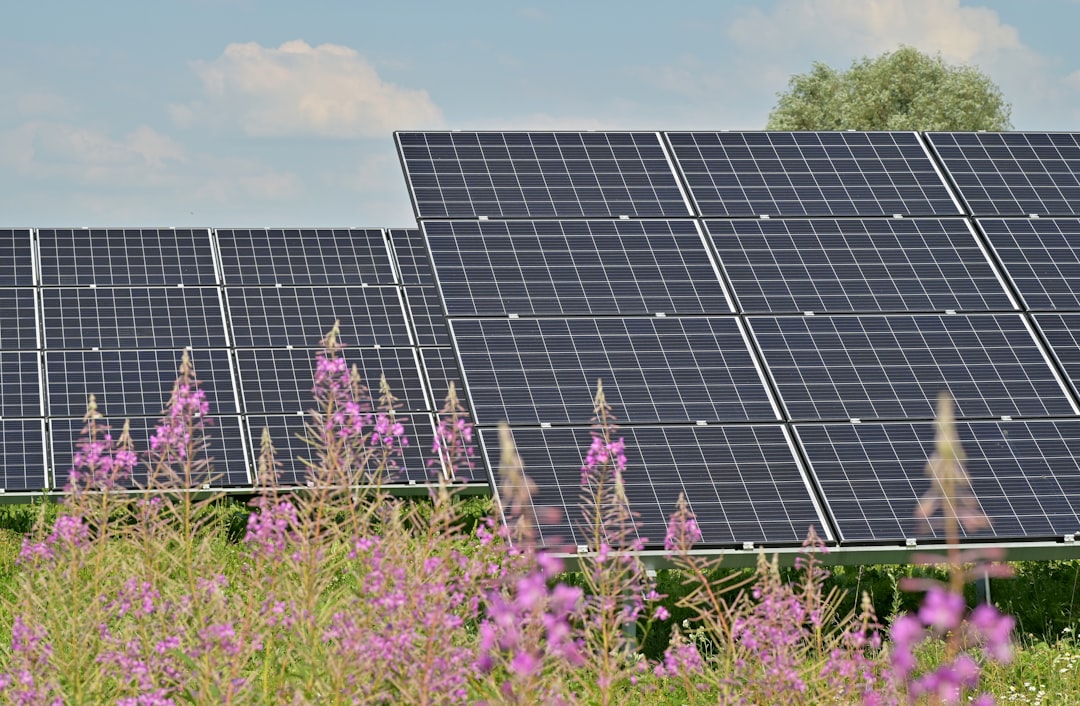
[0,329,1080,706]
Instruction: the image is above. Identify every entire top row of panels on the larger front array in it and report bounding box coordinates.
[397,132,1080,219]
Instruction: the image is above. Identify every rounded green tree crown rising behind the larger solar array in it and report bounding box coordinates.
[766,46,1012,131]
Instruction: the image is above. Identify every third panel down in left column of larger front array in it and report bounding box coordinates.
[450,316,778,424]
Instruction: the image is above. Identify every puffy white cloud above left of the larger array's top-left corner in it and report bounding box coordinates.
[170,40,443,138]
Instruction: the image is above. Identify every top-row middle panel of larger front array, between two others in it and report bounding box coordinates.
[665,132,961,217]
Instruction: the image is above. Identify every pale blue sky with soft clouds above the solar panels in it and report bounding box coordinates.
[0,0,1080,228]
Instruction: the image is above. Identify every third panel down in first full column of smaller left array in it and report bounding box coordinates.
[45,349,240,419]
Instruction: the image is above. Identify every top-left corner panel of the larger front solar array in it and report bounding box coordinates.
[395,132,692,218]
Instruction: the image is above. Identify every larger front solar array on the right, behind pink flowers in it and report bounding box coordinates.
[396,132,1080,546]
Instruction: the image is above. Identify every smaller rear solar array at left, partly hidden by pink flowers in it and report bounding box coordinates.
[0,229,464,492]
